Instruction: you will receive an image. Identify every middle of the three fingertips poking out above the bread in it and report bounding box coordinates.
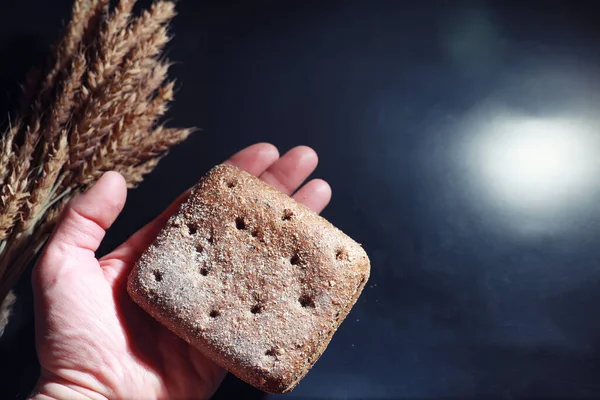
[260,146,319,195]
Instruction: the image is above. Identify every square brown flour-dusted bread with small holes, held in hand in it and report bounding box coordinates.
[128,164,370,393]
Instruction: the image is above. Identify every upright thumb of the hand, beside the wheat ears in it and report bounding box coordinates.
[35,172,127,286]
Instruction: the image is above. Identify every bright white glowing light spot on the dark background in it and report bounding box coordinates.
[468,114,600,215]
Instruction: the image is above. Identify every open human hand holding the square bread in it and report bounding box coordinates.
[32,144,331,399]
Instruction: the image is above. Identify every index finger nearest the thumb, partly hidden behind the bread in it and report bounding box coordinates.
[107,143,279,262]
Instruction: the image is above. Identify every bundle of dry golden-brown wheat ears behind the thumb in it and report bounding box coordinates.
[0,0,192,322]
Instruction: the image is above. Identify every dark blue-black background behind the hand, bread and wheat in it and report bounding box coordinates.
[0,0,600,399]
